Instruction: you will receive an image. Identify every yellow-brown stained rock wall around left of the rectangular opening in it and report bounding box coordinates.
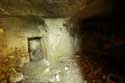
[0,17,43,70]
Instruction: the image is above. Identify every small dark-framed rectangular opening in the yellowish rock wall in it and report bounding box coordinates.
[28,37,43,61]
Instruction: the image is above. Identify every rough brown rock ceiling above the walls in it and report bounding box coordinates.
[0,0,111,17]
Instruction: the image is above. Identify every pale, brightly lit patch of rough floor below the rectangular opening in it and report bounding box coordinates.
[21,57,86,83]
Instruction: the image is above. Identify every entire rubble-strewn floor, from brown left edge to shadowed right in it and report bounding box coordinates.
[0,55,124,83]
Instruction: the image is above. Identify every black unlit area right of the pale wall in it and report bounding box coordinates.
[75,8,125,83]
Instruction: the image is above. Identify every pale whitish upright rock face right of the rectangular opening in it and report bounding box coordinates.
[44,18,79,63]
